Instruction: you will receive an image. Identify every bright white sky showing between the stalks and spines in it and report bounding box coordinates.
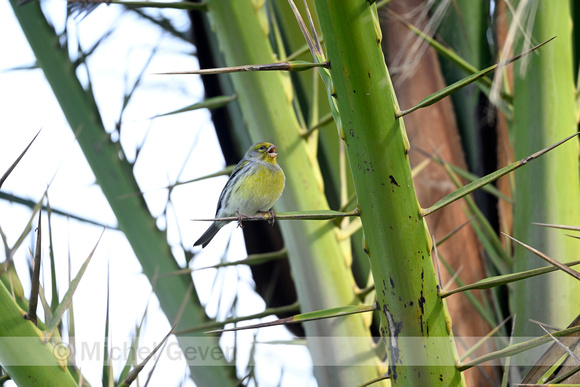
[0,0,316,386]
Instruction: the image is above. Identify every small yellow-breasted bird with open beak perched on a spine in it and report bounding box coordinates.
[193,142,286,248]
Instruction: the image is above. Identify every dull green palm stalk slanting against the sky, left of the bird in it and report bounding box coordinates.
[11,0,235,386]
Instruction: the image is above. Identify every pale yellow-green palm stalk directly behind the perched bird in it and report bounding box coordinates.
[208,0,379,386]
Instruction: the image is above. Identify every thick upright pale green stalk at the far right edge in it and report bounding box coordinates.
[512,1,580,336]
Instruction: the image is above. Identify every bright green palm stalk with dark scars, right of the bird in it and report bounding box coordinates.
[315,0,464,386]
